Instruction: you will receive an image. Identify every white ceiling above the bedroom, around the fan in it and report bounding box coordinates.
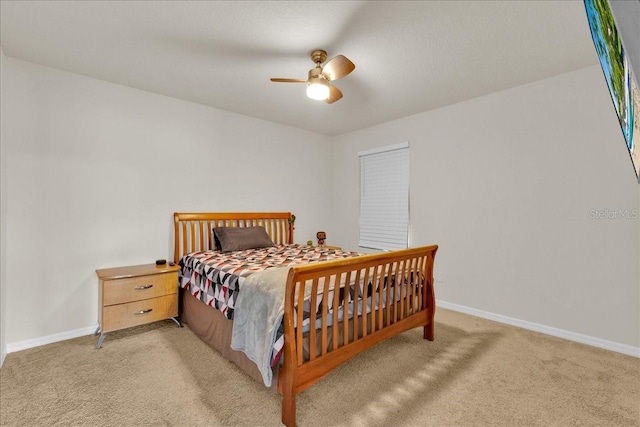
[0,0,598,135]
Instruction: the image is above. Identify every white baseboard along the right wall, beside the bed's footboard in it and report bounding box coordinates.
[437,300,640,357]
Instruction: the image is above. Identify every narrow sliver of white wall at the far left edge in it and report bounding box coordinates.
[0,48,7,366]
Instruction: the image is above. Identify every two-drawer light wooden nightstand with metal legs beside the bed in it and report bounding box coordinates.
[96,264,182,348]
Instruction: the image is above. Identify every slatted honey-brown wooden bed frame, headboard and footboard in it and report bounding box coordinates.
[174,212,438,426]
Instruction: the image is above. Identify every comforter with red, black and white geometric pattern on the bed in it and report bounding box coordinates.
[180,244,363,366]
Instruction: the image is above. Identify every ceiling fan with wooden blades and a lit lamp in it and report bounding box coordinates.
[271,49,356,104]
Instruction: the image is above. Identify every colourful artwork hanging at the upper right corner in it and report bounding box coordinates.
[584,0,640,183]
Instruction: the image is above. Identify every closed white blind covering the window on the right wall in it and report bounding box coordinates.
[358,142,409,250]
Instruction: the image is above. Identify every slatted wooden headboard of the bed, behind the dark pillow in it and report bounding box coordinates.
[173,212,296,263]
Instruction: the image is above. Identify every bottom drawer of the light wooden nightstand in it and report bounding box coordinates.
[101,296,178,333]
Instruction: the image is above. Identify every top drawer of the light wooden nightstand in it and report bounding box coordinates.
[102,273,178,306]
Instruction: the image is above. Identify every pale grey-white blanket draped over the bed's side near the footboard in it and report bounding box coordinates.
[231,267,289,387]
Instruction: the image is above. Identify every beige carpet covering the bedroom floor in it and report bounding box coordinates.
[0,309,640,427]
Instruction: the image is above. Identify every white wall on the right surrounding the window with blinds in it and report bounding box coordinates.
[332,65,640,354]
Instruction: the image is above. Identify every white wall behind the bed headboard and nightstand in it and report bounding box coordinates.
[2,57,330,351]
